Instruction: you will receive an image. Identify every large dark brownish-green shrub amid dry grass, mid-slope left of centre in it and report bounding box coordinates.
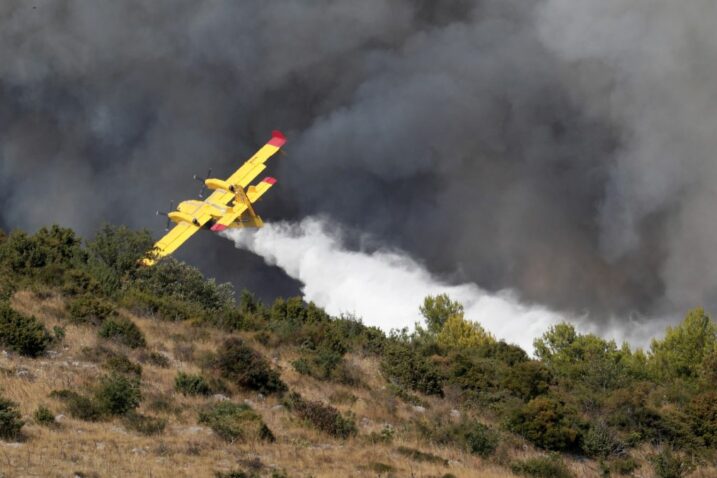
[213,338,287,394]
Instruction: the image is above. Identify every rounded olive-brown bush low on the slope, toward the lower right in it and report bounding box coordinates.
[508,396,582,451]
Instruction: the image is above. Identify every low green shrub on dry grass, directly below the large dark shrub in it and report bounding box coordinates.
[199,401,276,442]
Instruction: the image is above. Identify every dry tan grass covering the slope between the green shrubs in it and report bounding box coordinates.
[0,291,708,478]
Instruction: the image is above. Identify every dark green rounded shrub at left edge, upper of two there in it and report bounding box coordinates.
[0,304,52,357]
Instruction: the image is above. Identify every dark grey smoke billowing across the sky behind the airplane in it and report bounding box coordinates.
[0,0,717,320]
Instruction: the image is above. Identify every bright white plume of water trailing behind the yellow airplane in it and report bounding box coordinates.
[224,218,580,351]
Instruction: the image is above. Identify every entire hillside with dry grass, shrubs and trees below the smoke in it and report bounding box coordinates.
[0,226,717,478]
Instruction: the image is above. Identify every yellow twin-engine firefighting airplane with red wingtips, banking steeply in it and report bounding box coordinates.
[142,131,286,266]
